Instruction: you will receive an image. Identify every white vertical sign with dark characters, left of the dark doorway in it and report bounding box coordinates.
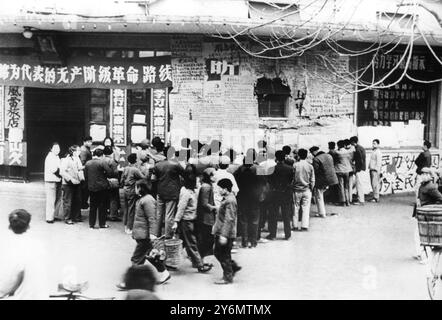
[5,86,25,129]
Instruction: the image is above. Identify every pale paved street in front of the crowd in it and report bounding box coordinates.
[0,182,428,299]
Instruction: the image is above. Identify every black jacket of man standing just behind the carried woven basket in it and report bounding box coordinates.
[153,160,184,200]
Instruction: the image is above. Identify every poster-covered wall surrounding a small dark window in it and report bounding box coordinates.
[169,36,354,150]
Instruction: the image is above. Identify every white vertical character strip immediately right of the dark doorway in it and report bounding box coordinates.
[111,89,127,146]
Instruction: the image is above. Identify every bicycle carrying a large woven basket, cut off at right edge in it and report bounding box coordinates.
[416,205,442,300]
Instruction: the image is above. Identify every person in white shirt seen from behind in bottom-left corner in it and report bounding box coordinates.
[0,209,49,300]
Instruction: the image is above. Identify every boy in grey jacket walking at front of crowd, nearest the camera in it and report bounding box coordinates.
[212,179,241,284]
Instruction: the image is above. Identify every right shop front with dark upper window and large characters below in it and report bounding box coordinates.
[356,47,442,194]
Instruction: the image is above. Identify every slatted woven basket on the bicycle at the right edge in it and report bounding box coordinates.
[416,205,442,246]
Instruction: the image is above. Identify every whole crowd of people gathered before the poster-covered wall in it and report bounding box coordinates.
[41,136,382,287]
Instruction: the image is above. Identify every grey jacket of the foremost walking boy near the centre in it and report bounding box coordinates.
[212,193,238,239]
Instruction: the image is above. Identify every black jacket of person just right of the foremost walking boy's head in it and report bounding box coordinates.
[233,165,265,204]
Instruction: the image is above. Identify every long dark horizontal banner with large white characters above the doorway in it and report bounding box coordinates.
[0,56,172,88]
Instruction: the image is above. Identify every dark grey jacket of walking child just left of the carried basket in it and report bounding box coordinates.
[132,194,156,240]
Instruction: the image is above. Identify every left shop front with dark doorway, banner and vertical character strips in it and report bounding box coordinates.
[0,51,172,181]
